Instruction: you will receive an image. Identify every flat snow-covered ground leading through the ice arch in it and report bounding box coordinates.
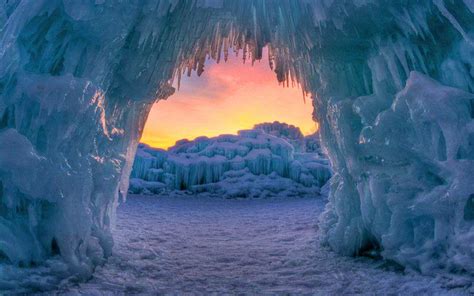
[59,195,468,295]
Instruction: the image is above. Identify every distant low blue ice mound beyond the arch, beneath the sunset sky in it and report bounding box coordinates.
[129,122,331,197]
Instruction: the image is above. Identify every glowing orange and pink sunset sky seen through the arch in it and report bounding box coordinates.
[141,49,316,148]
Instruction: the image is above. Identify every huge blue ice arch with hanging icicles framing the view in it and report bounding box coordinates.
[0,0,474,276]
